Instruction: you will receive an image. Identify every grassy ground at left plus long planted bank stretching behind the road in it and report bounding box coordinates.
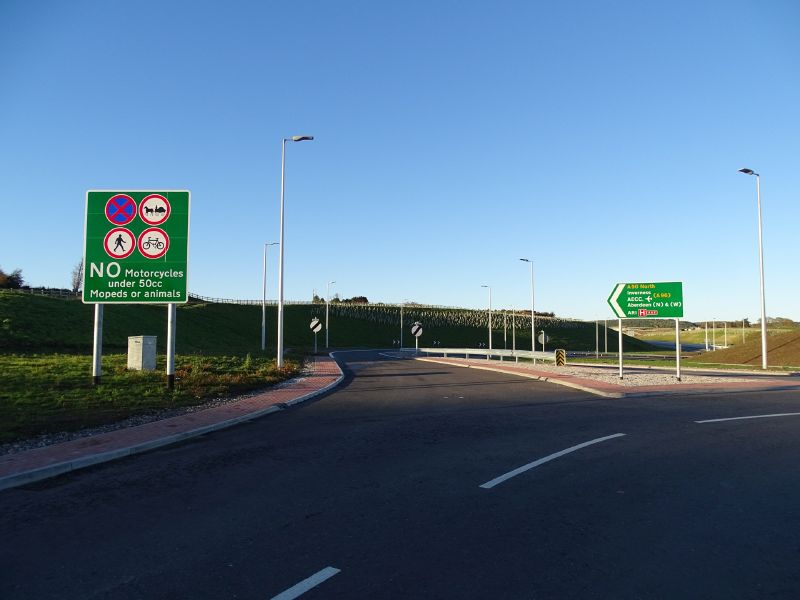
[0,291,646,442]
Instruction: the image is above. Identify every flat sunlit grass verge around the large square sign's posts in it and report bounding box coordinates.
[0,354,300,443]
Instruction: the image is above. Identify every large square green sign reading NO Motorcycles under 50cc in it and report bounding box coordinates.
[83,190,189,304]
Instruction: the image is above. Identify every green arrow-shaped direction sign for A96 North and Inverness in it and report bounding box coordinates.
[608,281,683,319]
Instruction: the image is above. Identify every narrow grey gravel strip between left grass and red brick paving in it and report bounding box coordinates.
[0,364,314,456]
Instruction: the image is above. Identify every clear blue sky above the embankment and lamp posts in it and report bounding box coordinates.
[0,0,800,320]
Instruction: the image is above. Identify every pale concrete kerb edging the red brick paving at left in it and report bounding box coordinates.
[0,353,344,490]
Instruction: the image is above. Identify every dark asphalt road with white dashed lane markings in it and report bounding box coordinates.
[0,352,800,600]
